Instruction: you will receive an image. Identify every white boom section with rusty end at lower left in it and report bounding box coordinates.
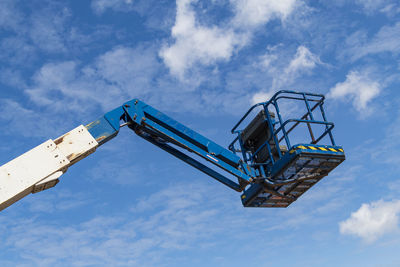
[0,125,99,210]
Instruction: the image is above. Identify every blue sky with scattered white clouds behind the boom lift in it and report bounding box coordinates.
[0,0,400,266]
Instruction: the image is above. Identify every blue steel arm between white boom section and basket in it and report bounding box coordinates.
[86,99,255,192]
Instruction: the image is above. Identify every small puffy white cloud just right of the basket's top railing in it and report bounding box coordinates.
[328,71,382,114]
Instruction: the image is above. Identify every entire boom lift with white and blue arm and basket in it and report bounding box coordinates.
[0,91,345,213]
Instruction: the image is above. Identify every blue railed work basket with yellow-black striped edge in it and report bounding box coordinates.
[229,91,345,207]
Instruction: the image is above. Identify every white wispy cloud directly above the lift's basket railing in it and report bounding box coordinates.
[227,45,320,107]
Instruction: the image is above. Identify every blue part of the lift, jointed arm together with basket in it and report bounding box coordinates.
[86,91,345,207]
